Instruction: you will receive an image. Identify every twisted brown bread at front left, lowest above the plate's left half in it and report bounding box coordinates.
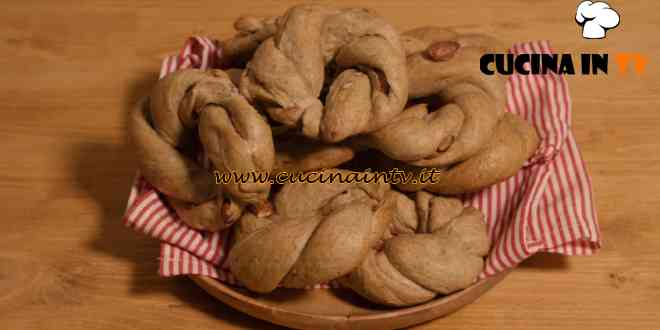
[228,171,391,292]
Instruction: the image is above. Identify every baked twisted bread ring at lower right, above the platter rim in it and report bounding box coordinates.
[340,192,490,306]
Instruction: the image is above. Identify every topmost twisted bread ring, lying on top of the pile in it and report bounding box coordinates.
[240,5,408,142]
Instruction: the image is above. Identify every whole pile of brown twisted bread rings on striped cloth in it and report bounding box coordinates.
[130,5,539,306]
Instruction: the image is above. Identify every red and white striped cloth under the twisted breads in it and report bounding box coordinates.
[124,37,601,284]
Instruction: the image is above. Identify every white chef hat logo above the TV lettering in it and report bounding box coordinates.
[575,1,620,39]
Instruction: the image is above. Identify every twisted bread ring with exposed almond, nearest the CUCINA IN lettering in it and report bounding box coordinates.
[357,27,505,167]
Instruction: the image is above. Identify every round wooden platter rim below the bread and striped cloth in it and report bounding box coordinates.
[190,272,507,330]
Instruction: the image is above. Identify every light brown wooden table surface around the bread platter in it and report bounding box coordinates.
[0,0,660,330]
